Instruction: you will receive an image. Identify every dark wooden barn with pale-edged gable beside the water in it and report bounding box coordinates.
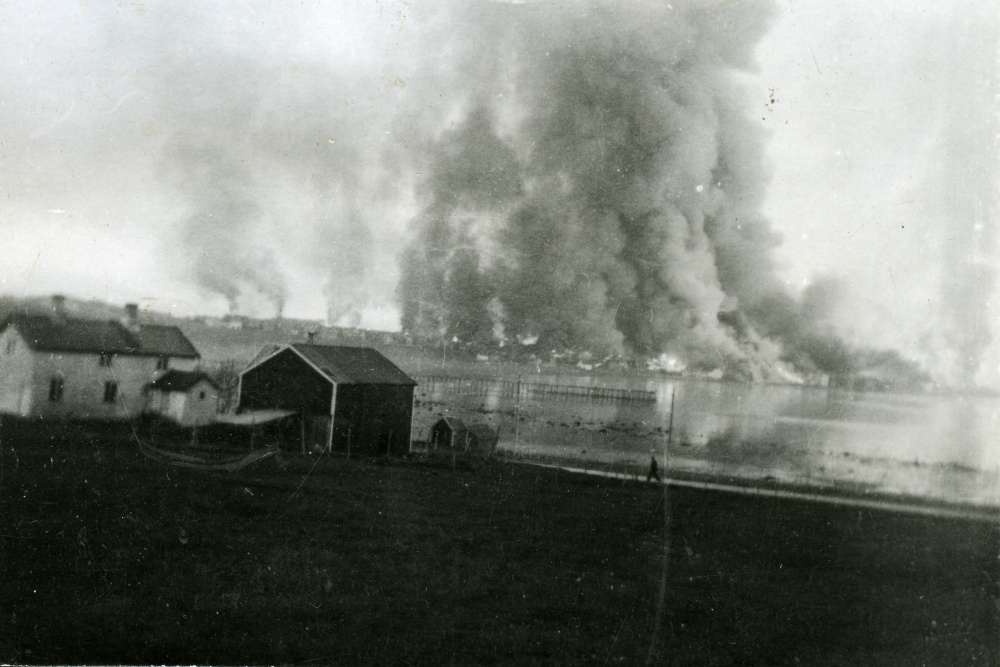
[239,343,417,455]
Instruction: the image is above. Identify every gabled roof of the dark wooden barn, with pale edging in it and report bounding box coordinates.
[241,343,417,387]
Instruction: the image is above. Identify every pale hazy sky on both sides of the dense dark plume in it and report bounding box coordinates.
[0,0,1000,383]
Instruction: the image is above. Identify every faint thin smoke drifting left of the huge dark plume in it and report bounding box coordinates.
[147,12,410,325]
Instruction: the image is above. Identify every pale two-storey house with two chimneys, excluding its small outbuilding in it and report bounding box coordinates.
[0,296,200,419]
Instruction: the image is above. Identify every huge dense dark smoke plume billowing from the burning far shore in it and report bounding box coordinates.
[399,3,820,374]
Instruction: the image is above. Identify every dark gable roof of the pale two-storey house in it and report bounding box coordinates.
[0,315,201,358]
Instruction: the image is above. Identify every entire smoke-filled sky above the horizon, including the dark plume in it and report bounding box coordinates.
[0,0,1000,385]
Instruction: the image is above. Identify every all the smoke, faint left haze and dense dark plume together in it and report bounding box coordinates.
[143,0,958,378]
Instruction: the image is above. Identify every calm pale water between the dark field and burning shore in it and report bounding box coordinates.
[415,375,1000,505]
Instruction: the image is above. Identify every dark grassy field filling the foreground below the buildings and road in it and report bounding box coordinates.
[0,426,1000,666]
